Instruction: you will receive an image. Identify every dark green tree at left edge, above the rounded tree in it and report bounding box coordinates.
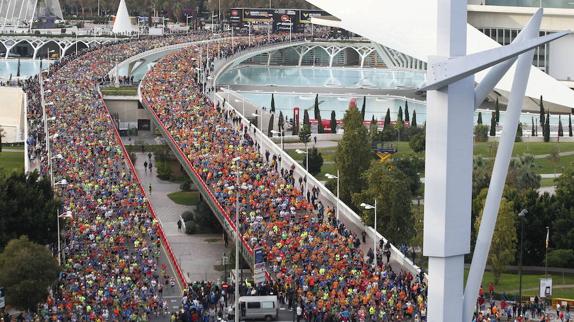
[0,172,58,249]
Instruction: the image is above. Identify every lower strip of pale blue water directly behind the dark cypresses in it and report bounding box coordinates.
[240,92,568,129]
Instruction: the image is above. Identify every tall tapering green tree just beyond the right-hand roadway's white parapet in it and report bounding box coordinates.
[335,106,372,203]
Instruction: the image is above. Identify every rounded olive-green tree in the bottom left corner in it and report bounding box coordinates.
[0,236,59,310]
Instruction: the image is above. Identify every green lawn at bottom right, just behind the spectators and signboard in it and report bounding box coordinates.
[464,269,574,299]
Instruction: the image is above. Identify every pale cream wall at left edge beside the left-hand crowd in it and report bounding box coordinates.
[0,87,25,143]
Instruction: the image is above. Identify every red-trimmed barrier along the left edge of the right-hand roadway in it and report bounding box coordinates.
[140,92,254,266]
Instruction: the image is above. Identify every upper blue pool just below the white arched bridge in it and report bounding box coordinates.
[218,66,426,89]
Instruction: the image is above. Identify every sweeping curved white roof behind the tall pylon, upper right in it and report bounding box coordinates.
[307,0,574,108]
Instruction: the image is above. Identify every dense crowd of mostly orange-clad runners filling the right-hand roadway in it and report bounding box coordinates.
[142,38,426,321]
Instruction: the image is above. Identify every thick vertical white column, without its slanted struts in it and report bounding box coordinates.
[423,0,474,322]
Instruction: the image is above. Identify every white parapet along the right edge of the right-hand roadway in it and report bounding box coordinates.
[215,93,420,275]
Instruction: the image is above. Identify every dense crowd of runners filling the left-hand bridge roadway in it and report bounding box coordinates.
[20,35,218,321]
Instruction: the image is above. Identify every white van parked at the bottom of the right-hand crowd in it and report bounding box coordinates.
[230,295,279,321]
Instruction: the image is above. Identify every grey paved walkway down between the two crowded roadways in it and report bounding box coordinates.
[134,152,230,282]
